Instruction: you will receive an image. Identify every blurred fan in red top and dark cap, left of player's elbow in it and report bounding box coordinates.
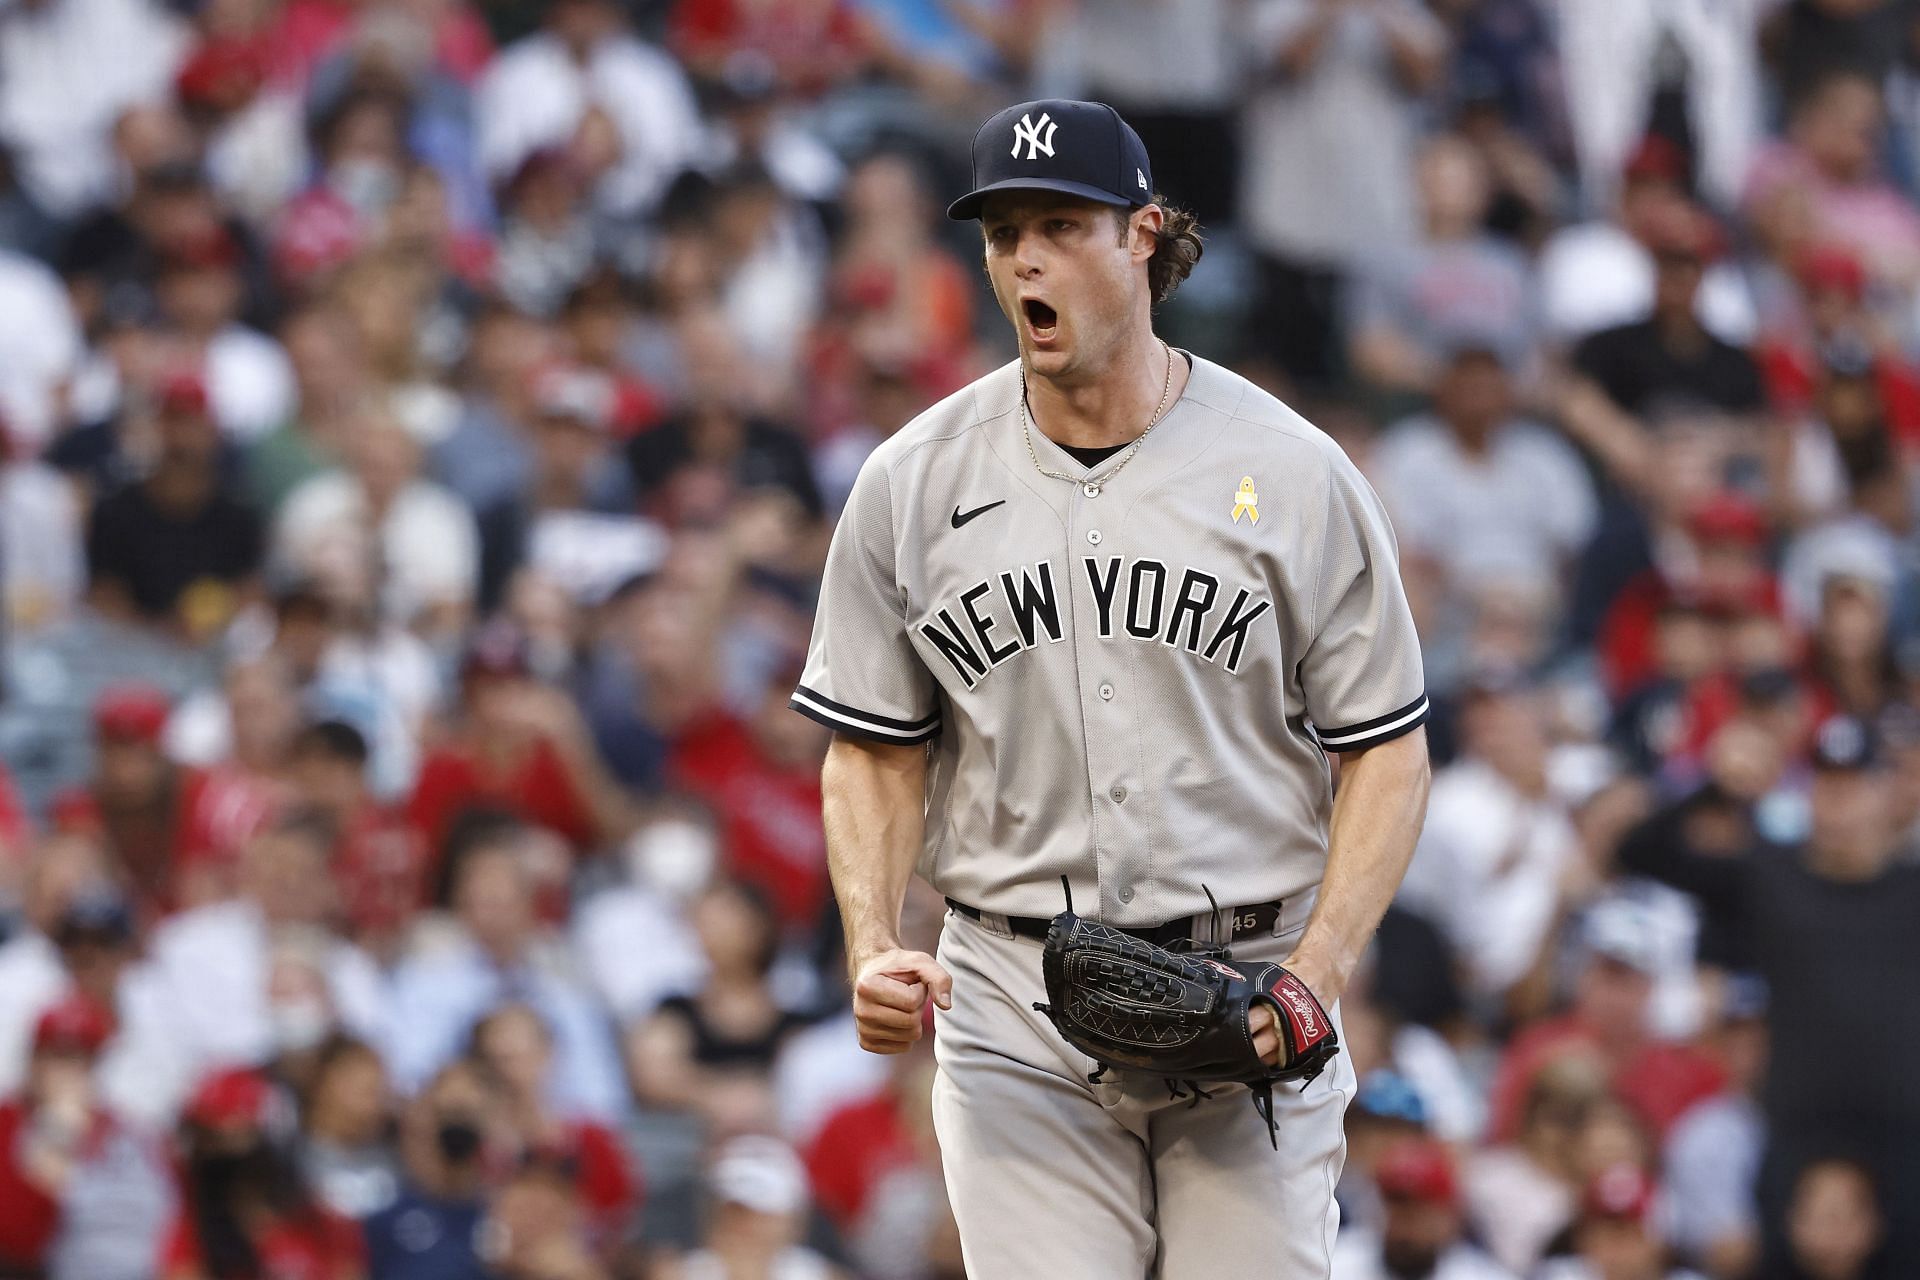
[407,624,632,860]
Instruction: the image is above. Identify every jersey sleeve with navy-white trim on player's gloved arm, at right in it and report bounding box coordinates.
[1300,453,1427,750]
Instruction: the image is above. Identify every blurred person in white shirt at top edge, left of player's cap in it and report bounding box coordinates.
[474,0,707,217]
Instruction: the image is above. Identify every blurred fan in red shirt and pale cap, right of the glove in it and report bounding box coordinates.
[1488,904,1726,1142]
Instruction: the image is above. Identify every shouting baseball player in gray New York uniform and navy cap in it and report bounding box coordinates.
[793,100,1427,1280]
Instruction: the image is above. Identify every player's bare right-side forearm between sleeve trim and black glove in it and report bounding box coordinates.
[1286,729,1428,1004]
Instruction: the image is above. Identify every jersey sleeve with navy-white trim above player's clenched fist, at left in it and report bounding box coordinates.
[789,459,941,745]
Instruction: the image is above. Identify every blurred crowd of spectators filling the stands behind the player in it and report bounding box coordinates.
[0,0,1920,1280]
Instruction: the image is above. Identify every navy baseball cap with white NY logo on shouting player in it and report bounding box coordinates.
[947,98,1154,223]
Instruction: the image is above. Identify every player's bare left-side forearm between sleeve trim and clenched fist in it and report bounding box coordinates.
[820,737,927,967]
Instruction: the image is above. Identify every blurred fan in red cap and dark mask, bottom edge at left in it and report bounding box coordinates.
[159,1071,367,1280]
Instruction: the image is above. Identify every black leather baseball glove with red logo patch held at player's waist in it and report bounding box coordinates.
[1033,908,1340,1136]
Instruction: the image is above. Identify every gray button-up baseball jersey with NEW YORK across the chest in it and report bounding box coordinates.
[793,359,1427,925]
